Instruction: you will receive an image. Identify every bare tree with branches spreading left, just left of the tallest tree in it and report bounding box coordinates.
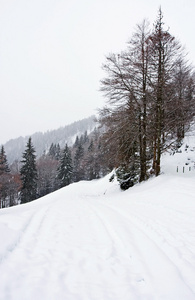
[101,20,150,181]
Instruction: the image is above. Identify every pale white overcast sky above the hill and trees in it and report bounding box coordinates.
[0,0,195,144]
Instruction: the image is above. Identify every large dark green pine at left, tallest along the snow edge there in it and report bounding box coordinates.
[20,138,37,203]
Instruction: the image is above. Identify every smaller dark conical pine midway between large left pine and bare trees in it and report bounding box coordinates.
[57,144,73,188]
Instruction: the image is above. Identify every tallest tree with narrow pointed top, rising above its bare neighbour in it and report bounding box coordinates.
[149,8,182,176]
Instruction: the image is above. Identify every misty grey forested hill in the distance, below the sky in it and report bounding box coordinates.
[4,116,96,163]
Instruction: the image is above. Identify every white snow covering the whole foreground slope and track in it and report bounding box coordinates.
[0,134,195,300]
